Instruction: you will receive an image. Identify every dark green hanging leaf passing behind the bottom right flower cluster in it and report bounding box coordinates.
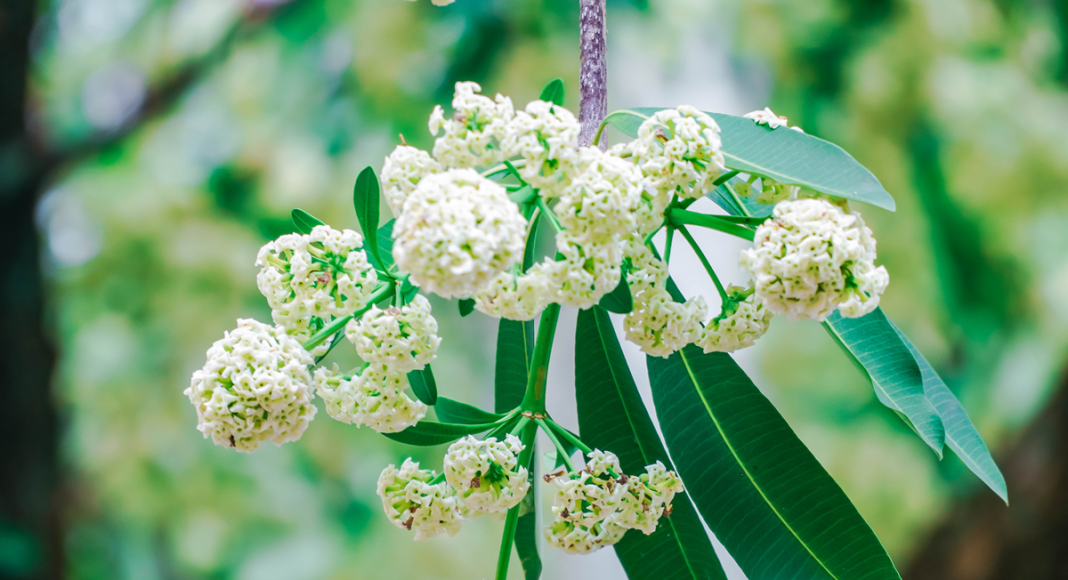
[575,307,726,580]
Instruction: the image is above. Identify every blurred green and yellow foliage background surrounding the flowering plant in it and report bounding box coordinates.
[6,0,1068,580]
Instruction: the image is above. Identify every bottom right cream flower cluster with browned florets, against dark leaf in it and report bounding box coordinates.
[545,450,682,553]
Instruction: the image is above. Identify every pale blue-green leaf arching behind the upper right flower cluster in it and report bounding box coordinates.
[606,107,895,211]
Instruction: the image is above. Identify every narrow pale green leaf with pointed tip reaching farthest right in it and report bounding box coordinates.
[888,320,1008,504]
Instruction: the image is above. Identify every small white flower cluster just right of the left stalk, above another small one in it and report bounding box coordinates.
[345,295,441,373]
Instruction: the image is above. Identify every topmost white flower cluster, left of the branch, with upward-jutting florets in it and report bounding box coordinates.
[428,82,515,169]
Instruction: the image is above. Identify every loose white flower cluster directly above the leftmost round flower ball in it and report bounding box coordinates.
[256,225,378,355]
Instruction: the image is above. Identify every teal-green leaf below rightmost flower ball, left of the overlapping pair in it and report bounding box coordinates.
[823,309,945,458]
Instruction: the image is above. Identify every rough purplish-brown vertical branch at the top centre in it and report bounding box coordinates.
[579,0,608,150]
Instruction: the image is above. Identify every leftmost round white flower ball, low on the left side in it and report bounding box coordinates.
[185,318,315,452]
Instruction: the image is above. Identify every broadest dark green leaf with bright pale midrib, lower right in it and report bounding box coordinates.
[646,345,900,580]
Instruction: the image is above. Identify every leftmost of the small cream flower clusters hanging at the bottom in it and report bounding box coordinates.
[378,457,464,542]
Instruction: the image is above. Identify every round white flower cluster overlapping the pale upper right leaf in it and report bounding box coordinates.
[630,106,726,198]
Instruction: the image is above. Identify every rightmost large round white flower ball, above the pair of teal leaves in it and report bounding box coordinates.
[741,199,890,320]
